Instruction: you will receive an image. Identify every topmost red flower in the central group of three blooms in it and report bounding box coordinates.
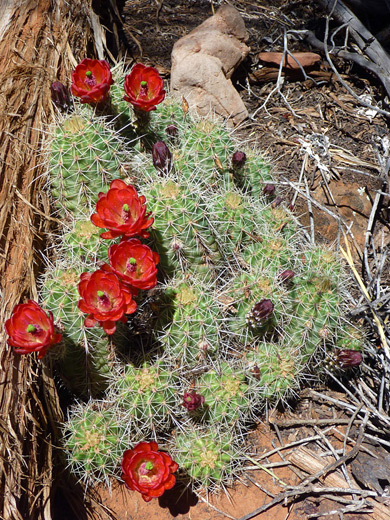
[91,179,154,239]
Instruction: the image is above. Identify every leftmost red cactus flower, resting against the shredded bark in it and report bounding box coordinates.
[5,300,62,359]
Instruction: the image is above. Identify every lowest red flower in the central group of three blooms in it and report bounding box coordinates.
[78,269,137,334]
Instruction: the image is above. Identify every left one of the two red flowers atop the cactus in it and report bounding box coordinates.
[72,58,114,105]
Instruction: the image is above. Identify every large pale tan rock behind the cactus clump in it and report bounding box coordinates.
[171,5,250,125]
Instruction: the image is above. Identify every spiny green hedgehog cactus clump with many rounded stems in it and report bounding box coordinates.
[40,64,362,489]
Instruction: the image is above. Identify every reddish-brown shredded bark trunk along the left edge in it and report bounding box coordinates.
[0,0,108,520]
